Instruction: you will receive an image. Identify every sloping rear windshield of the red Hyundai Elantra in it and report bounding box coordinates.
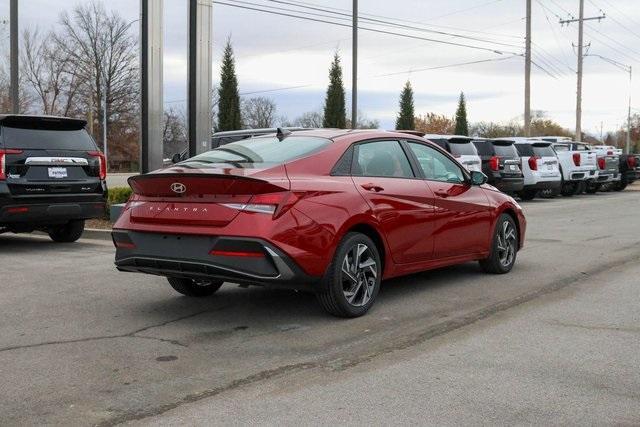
[183,136,331,165]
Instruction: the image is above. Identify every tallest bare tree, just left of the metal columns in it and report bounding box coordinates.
[55,0,139,150]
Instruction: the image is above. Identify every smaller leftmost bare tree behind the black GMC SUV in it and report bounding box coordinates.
[21,29,82,116]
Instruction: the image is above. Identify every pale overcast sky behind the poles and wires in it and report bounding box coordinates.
[0,0,640,136]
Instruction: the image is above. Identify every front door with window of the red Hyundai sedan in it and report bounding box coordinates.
[408,142,491,259]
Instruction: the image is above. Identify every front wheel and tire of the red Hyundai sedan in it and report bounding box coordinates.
[479,214,519,274]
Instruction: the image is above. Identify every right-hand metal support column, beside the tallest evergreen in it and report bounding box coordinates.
[187,0,213,156]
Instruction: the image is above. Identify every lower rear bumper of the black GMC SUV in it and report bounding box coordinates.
[0,200,106,225]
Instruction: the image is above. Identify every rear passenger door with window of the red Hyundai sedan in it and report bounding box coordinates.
[352,141,434,263]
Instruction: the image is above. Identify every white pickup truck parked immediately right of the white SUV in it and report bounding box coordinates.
[543,144,598,196]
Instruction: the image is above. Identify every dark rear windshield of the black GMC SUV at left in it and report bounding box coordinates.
[2,126,96,151]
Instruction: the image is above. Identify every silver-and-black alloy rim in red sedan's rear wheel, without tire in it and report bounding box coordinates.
[341,243,378,307]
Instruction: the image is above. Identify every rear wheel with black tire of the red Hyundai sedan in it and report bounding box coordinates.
[316,233,382,318]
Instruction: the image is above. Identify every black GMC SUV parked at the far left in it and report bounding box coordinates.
[0,115,107,242]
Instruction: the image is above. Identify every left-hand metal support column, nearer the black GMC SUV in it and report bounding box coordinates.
[140,0,164,173]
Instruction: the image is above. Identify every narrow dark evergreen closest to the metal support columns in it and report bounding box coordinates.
[218,39,242,131]
